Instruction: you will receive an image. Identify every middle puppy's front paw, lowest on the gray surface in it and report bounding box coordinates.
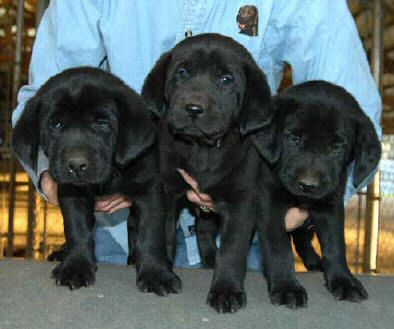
[207,285,246,313]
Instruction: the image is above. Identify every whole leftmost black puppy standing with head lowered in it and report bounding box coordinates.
[13,67,180,295]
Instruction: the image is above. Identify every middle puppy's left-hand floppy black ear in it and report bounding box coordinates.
[141,52,172,112]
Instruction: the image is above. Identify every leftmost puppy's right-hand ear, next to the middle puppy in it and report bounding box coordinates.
[115,87,157,168]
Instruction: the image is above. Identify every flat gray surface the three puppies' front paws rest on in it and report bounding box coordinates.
[0,260,394,329]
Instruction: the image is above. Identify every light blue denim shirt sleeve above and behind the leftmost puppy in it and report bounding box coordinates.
[12,0,105,191]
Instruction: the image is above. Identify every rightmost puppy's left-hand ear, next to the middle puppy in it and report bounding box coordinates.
[251,96,284,164]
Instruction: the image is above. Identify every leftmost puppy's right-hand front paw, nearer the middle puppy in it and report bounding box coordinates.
[137,270,182,296]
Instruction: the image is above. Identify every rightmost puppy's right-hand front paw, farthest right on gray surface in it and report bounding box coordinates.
[326,276,368,302]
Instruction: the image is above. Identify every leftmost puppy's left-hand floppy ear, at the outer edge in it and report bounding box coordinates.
[12,96,41,171]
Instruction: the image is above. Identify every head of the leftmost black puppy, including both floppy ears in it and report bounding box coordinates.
[13,68,155,184]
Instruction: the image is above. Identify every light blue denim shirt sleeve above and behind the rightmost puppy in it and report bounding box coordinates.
[283,0,382,201]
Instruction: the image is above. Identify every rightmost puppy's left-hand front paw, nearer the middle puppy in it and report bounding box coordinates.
[270,280,308,309]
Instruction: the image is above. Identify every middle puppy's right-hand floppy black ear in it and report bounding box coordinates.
[240,63,272,136]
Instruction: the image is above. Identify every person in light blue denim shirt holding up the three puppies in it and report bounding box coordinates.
[12,0,382,269]
